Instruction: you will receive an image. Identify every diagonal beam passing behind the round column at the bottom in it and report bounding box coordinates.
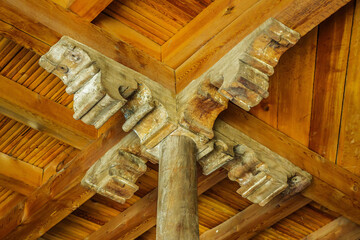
[86,169,227,240]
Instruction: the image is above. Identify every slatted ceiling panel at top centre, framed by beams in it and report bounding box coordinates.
[94,0,212,45]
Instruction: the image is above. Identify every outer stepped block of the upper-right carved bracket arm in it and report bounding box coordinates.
[203,18,300,111]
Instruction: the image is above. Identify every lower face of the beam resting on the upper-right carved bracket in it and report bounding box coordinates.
[176,0,348,92]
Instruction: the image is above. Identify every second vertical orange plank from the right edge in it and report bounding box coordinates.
[308,2,354,162]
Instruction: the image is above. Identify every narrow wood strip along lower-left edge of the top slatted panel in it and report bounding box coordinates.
[94,14,161,60]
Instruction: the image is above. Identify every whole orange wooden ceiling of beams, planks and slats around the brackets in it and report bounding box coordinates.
[0,0,360,240]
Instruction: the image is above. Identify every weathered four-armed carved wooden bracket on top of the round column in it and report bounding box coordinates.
[40,19,311,205]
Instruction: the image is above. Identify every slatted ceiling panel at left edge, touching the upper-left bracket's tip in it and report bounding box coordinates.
[0,37,73,108]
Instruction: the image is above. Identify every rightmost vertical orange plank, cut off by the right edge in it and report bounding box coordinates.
[337,0,360,175]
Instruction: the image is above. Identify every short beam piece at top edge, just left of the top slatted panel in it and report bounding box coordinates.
[69,0,113,22]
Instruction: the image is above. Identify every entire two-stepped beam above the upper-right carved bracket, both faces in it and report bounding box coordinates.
[174,0,350,92]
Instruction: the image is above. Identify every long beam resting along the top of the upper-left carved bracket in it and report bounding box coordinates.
[0,0,175,91]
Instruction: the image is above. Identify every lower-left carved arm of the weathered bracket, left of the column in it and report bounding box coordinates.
[81,134,147,203]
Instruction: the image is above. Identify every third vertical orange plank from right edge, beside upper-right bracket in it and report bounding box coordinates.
[276,29,317,146]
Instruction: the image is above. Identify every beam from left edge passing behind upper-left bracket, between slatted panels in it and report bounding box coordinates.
[0,76,97,149]
